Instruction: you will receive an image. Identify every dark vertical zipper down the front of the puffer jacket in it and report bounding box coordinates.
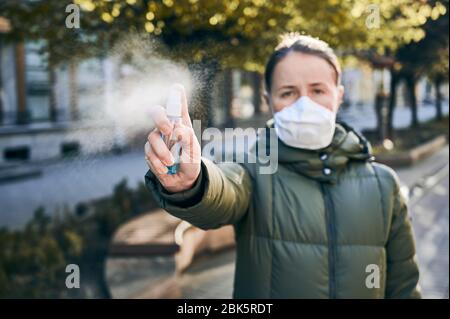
[320,183,336,299]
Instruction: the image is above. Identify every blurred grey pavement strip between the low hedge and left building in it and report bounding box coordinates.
[0,151,148,228]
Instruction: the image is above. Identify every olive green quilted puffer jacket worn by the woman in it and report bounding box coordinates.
[145,120,420,298]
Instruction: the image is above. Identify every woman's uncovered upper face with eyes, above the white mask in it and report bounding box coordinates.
[267,52,344,113]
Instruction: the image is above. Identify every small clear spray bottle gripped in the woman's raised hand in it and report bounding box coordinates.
[161,86,181,175]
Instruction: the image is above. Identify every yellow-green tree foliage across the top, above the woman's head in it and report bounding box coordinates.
[4,0,445,71]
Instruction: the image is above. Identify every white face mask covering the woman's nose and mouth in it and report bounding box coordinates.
[274,96,336,150]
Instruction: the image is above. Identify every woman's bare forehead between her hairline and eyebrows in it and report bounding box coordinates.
[272,52,335,88]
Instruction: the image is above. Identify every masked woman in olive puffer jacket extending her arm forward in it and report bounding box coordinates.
[145,34,420,298]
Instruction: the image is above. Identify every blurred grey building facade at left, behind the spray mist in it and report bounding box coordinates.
[0,39,115,165]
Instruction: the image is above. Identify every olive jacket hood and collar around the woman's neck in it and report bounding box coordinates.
[263,118,373,182]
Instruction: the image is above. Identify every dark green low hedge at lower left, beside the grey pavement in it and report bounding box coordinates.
[0,180,154,298]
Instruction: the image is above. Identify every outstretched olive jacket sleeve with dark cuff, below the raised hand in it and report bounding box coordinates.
[145,158,252,229]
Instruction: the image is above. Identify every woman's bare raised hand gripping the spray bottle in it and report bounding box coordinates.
[145,85,201,193]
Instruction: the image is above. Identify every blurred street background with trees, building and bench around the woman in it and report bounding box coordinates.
[0,0,449,298]
